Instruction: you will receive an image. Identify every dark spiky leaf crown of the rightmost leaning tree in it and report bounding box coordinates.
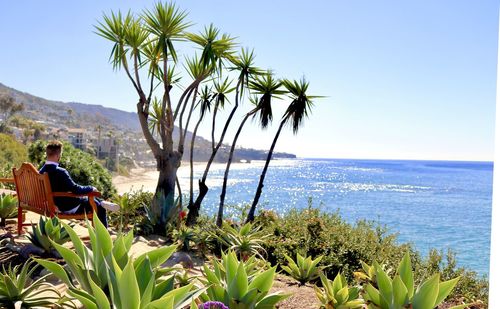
[283,78,321,134]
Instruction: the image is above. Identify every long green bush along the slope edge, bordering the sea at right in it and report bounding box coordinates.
[256,205,488,302]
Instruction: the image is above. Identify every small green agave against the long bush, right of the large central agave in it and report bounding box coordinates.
[281,252,326,284]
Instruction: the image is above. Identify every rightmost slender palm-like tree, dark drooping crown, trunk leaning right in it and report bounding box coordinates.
[246,79,319,222]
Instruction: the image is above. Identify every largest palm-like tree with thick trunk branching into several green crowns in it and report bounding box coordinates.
[96,3,234,230]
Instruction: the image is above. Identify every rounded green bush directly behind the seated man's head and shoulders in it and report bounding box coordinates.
[28,141,116,199]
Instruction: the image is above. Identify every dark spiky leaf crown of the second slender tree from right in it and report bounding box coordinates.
[249,72,285,129]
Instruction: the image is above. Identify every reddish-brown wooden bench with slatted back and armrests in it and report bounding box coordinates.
[12,163,101,234]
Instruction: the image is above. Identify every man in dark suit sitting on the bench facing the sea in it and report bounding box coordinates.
[39,141,120,227]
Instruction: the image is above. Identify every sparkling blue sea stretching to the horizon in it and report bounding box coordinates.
[175,159,493,276]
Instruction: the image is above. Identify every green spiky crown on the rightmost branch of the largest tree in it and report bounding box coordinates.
[186,24,236,71]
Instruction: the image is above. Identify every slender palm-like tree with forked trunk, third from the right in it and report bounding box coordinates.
[186,49,263,225]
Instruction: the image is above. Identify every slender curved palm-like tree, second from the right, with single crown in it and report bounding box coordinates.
[216,72,284,227]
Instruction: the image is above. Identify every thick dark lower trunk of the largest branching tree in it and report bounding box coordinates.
[152,151,181,227]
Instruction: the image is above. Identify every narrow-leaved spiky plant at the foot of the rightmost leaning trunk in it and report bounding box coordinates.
[215,222,268,260]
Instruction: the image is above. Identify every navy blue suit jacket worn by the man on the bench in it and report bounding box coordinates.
[39,164,94,212]
